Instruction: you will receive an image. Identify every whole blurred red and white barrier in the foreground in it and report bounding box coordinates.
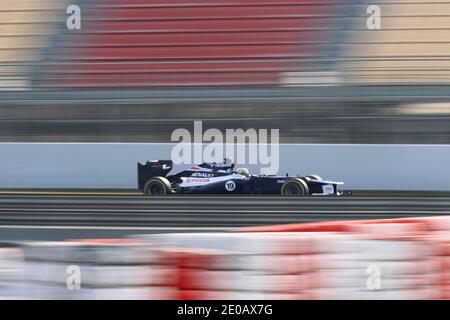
[0,216,450,299]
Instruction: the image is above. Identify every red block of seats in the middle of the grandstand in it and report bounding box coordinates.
[46,0,342,88]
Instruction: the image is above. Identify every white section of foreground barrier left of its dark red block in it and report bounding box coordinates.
[2,239,160,299]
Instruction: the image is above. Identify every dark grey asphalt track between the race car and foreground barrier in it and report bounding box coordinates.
[0,194,450,240]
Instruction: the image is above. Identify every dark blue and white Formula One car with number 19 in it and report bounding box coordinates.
[138,159,350,196]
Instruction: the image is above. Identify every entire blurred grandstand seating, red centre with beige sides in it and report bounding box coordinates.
[0,0,450,90]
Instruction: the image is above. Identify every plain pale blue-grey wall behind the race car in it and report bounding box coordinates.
[0,143,450,191]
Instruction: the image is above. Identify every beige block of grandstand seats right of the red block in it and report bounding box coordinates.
[339,0,450,84]
